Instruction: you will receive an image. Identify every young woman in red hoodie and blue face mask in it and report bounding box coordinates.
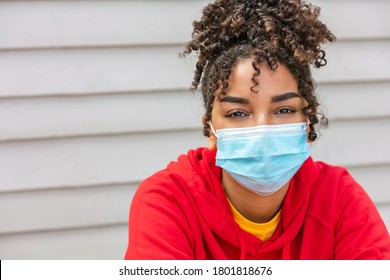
[125,0,390,259]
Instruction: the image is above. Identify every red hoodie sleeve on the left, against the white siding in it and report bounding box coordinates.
[125,172,194,260]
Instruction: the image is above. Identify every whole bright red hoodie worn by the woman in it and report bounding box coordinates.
[125,148,390,260]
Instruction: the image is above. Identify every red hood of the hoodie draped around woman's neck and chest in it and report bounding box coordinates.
[168,148,321,259]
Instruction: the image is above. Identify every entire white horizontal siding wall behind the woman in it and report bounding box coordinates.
[0,0,390,259]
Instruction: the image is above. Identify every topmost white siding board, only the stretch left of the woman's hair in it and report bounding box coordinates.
[0,0,207,49]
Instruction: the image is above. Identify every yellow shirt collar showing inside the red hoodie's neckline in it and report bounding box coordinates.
[228,199,281,241]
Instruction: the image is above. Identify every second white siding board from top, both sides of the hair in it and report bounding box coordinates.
[0,40,390,97]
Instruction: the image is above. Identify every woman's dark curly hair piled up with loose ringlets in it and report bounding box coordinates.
[183,0,336,136]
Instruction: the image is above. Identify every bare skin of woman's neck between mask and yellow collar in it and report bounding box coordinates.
[222,171,289,223]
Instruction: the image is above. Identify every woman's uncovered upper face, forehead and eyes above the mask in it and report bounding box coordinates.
[209,59,307,149]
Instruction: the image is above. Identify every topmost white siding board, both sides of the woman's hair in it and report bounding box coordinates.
[0,0,390,49]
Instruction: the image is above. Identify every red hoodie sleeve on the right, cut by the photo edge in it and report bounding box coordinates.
[335,171,390,260]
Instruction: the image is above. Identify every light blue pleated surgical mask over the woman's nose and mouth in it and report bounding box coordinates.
[210,123,310,194]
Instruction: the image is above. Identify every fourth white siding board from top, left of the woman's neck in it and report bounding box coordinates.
[0,129,206,191]
